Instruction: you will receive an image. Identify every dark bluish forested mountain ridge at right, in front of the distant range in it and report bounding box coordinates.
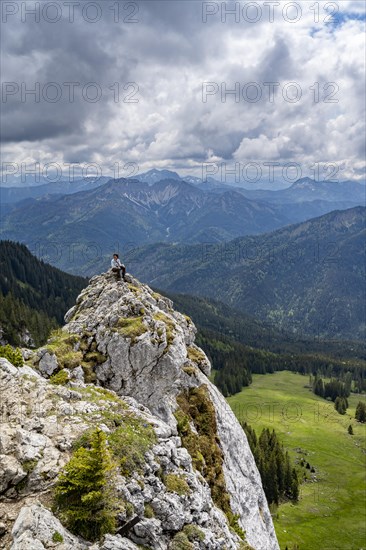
[125,207,366,339]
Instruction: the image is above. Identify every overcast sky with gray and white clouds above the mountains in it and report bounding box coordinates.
[1,0,365,187]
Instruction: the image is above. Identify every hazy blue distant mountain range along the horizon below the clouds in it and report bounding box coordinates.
[0,170,365,273]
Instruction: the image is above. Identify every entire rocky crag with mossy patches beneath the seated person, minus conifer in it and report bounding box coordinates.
[0,273,279,550]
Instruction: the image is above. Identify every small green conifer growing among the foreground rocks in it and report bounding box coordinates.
[55,429,117,541]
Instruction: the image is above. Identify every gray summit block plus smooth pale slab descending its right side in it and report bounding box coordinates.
[65,275,278,550]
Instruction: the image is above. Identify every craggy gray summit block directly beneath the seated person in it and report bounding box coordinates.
[65,275,197,425]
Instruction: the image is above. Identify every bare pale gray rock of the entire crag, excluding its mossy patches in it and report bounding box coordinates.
[0,275,279,550]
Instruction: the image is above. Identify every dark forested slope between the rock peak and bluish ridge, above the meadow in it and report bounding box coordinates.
[165,293,366,396]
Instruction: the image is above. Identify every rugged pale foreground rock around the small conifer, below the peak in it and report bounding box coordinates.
[0,360,243,550]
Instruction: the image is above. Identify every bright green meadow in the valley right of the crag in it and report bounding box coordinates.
[228,371,366,550]
